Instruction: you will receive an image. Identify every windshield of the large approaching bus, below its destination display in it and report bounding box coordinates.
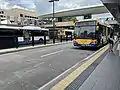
[75,21,96,38]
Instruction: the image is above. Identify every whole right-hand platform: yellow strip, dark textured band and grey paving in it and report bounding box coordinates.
[51,42,120,90]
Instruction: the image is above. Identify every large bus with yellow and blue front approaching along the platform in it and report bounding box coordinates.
[73,20,112,47]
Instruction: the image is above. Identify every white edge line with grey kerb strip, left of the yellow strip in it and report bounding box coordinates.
[37,45,108,90]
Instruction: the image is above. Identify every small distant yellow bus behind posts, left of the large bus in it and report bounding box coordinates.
[58,29,74,39]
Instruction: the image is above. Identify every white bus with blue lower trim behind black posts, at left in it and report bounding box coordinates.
[18,26,49,44]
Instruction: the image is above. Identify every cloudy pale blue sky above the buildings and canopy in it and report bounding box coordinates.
[0,0,112,15]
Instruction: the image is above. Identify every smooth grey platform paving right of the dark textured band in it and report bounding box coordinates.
[78,42,120,90]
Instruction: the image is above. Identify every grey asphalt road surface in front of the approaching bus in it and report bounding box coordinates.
[0,43,94,90]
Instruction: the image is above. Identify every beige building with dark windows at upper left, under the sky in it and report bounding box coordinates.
[0,8,38,24]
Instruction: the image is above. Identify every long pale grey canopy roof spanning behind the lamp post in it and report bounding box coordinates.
[39,4,109,18]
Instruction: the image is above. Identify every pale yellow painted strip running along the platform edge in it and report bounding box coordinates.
[50,45,109,90]
